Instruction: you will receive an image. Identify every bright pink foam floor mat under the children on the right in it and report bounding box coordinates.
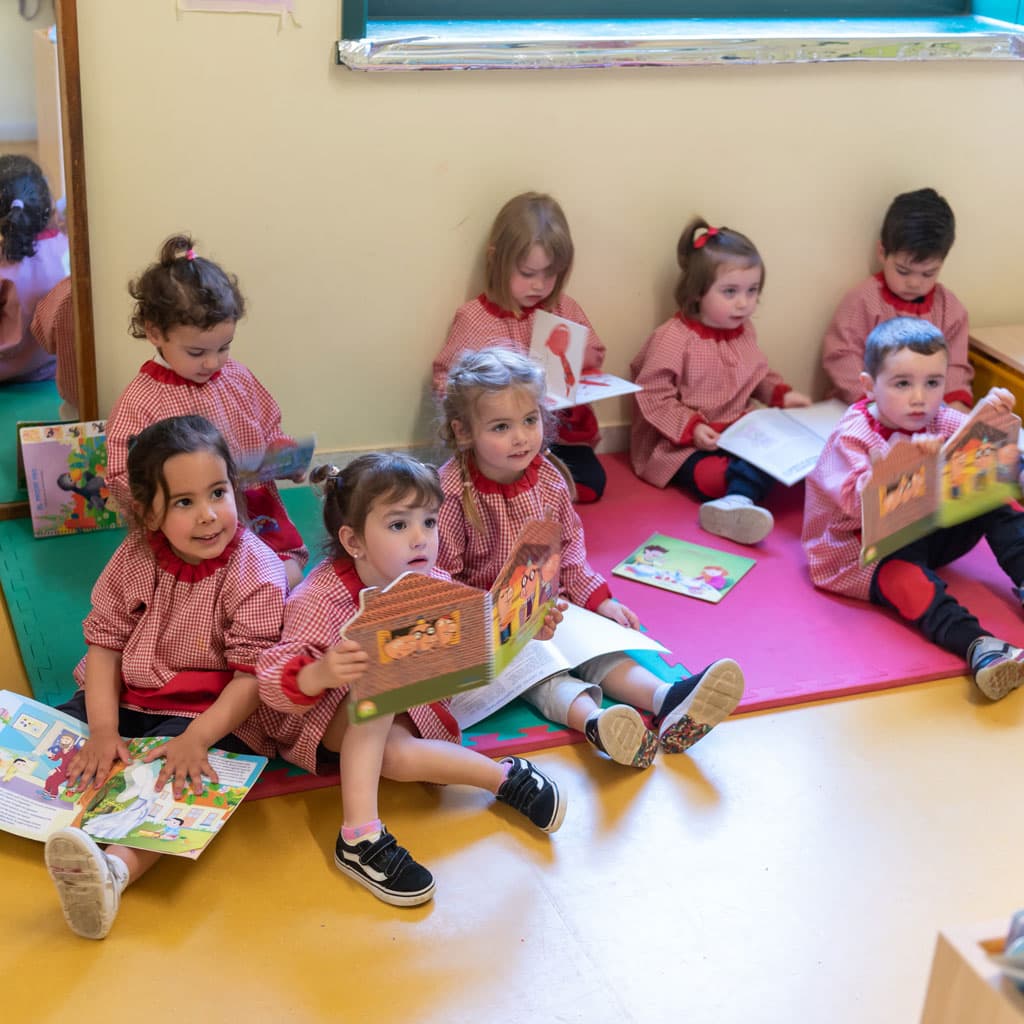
[579,453,1024,711]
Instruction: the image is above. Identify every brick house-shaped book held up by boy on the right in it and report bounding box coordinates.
[860,401,1021,565]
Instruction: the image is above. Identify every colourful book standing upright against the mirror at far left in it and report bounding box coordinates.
[18,420,122,537]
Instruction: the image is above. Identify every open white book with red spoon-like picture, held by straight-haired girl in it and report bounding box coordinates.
[529,309,641,409]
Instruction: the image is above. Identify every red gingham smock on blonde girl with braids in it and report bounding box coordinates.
[437,454,611,611]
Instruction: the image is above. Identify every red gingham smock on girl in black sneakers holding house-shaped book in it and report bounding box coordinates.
[256,559,462,773]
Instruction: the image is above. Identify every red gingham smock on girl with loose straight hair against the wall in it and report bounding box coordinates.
[433,293,605,444]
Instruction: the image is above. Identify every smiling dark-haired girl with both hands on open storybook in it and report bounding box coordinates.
[46,416,288,939]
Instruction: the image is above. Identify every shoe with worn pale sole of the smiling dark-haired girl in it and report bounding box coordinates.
[45,828,128,939]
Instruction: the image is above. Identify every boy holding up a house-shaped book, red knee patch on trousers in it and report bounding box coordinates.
[801,316,1024,700]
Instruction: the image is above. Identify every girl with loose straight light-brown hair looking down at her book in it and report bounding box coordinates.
[434,193,605,502]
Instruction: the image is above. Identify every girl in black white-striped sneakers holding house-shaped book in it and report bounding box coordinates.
[256,453,565,906]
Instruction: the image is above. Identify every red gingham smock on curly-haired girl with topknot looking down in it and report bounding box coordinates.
[106,359,309,565]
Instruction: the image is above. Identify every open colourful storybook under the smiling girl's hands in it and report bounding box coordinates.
[0,690,266,860]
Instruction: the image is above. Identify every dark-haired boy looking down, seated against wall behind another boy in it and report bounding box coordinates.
[821,188,974,412]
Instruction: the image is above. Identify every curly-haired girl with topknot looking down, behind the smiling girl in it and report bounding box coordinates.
[106,234,309,587]
